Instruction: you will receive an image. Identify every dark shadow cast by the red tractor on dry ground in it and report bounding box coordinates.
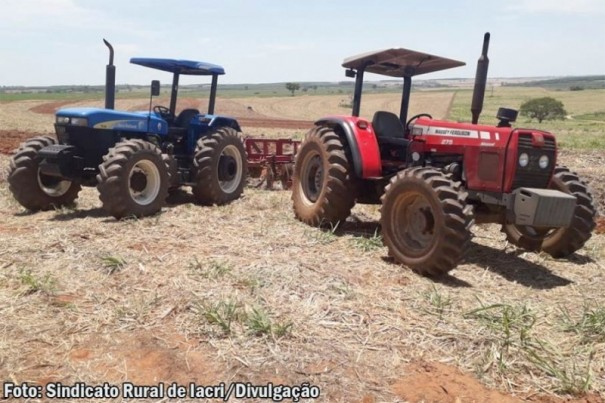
[322,221,572,290]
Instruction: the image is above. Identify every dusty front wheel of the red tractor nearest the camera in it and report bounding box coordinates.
[380,167,473,276]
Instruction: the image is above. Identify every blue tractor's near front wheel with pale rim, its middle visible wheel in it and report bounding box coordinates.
[97,139,170,219]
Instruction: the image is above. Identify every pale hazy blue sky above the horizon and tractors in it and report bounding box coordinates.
[0,0,605,86]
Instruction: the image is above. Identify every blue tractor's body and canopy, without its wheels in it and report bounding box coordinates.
[47,47,241,188]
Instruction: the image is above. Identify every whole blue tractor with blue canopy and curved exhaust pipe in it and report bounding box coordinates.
[8,41,248,219]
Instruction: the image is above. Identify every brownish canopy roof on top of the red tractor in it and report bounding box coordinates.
[342,48,466,77]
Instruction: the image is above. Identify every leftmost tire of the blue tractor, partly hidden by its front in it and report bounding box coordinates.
[8,136,82,211]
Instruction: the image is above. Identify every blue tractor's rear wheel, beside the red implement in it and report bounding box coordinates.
[193,127,248,206]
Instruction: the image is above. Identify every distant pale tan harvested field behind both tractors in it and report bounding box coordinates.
[0,92,453,134]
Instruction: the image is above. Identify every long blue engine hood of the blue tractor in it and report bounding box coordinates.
[56,108,168,134]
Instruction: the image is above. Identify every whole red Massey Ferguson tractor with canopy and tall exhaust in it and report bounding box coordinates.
[292,33,596,276]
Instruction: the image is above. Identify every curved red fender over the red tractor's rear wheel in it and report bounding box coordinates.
[315,116,382,179]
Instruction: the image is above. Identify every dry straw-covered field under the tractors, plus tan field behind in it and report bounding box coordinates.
[0,92,605,402]
